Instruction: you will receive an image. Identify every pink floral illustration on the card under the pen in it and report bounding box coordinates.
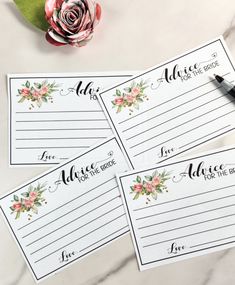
[112,80,149,115]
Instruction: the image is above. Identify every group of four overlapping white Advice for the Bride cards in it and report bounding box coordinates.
[1,38,235,281]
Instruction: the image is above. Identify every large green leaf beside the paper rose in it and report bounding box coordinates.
[14,0,49,31]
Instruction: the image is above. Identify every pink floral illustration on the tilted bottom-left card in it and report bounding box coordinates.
[10,183,47,220]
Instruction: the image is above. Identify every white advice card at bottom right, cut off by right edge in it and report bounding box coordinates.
[119,147,235,270]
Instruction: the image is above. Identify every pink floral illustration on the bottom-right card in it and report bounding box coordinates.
[130,171,170,204]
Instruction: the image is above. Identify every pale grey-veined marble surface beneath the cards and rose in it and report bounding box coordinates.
[0,0,235,285]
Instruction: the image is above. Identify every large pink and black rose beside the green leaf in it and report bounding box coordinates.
[45,0,101,47]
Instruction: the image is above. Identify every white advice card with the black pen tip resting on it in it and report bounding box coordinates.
[98,38,235,168]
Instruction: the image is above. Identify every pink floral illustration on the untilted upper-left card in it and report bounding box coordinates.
[17,80,59,110]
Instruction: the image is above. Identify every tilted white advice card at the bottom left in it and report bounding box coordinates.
[1,137,129,281]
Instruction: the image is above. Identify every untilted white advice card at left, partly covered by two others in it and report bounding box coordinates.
[8,72,133,166]
